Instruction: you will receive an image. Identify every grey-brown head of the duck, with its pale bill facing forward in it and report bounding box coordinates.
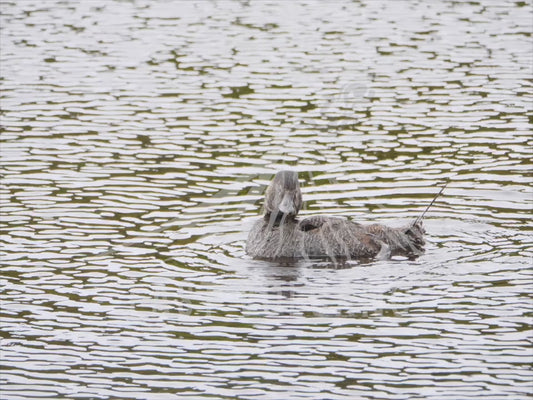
[265,171,302,221]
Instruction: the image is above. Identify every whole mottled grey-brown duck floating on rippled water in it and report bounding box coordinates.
[246,170,425,261]
